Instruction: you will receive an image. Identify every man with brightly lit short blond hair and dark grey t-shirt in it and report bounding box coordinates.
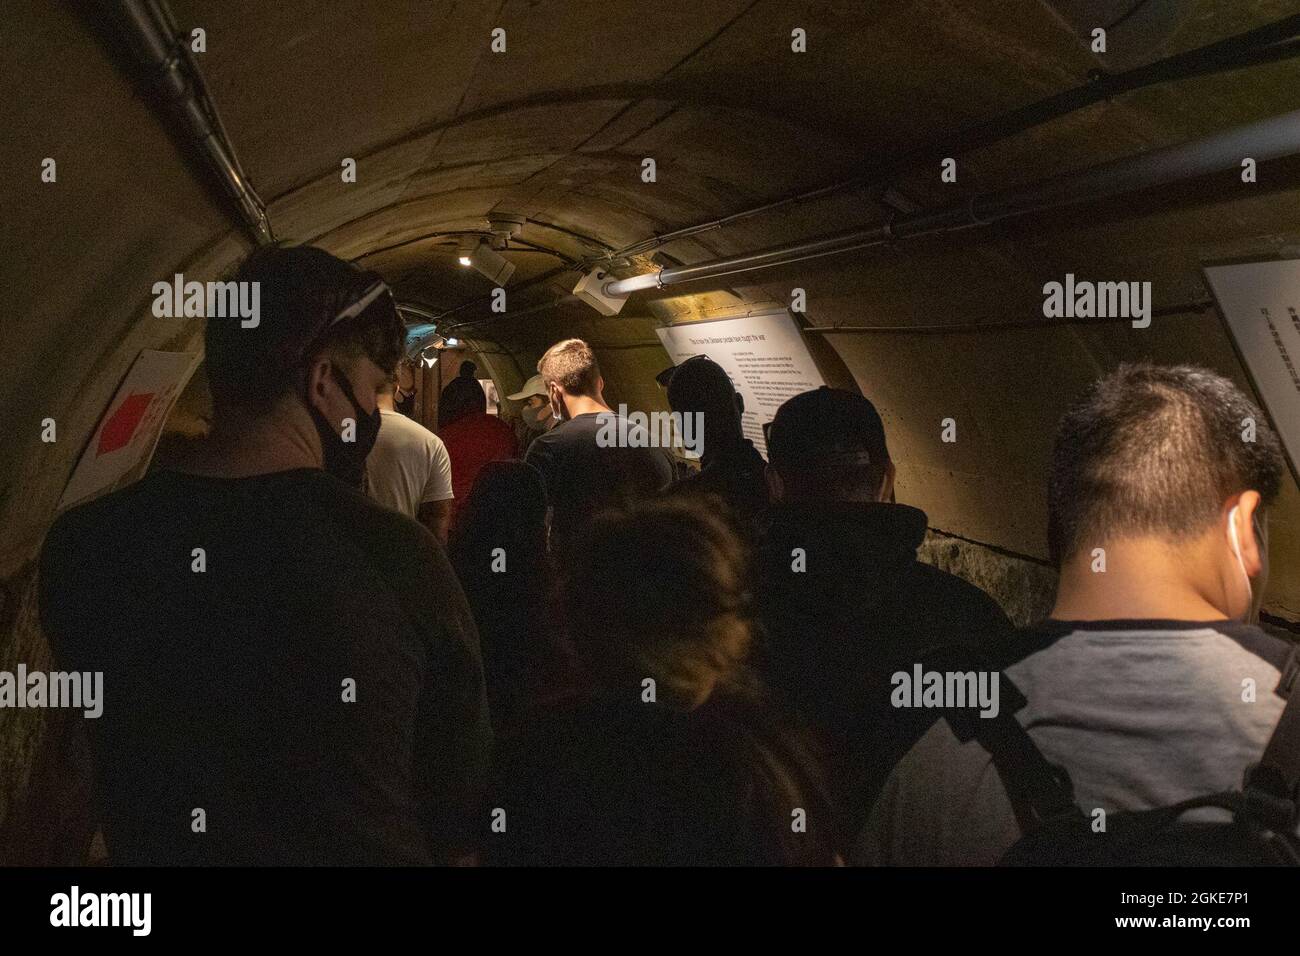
[524,338,673,546]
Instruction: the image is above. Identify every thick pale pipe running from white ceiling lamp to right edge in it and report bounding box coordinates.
[603,111,1300,297]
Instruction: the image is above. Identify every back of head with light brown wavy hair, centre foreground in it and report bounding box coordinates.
[563,498,751,710]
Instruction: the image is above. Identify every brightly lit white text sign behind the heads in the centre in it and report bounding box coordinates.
[655,310,826,458]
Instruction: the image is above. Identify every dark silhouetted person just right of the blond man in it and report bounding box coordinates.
[668,355,767,535]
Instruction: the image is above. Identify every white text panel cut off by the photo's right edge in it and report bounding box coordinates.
[1205,259,1300,481]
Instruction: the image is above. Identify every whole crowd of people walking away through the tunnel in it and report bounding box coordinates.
[40,246,1290,865]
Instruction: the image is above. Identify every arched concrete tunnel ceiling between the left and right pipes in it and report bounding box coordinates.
[167,0,1294,321]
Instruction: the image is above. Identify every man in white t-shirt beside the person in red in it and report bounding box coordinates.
[365,377,452,544]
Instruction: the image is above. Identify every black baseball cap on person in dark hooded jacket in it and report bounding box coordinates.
[764,385,889,467]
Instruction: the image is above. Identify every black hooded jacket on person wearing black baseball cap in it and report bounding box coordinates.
[755,502,1011,827]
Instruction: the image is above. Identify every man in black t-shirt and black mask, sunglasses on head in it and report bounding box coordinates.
[40,246,491,865]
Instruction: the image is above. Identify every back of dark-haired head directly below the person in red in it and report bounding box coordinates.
[452,462,546,580]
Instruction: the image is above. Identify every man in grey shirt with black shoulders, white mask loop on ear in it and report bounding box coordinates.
[858,364,1288,865]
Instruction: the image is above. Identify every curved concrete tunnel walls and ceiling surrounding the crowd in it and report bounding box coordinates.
[0,0,1300,860]
